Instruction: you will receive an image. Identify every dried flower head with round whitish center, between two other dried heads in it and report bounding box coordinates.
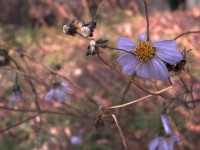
[81,19,97,37]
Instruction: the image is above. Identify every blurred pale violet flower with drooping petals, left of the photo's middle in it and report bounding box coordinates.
[45,82,72,102]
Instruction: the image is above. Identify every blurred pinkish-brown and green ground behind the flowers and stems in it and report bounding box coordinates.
[0,0,200,150]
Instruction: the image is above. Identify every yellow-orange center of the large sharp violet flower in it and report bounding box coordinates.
[135,41,154,61]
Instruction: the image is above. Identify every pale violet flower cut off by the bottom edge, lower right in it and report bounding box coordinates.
[149,135,180,150]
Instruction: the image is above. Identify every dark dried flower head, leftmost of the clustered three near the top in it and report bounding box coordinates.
[63,19,78,36]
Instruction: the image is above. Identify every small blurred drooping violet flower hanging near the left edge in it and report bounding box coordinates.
[10,85,24,102]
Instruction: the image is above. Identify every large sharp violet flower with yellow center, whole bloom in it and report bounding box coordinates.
[117,34,183,80]
